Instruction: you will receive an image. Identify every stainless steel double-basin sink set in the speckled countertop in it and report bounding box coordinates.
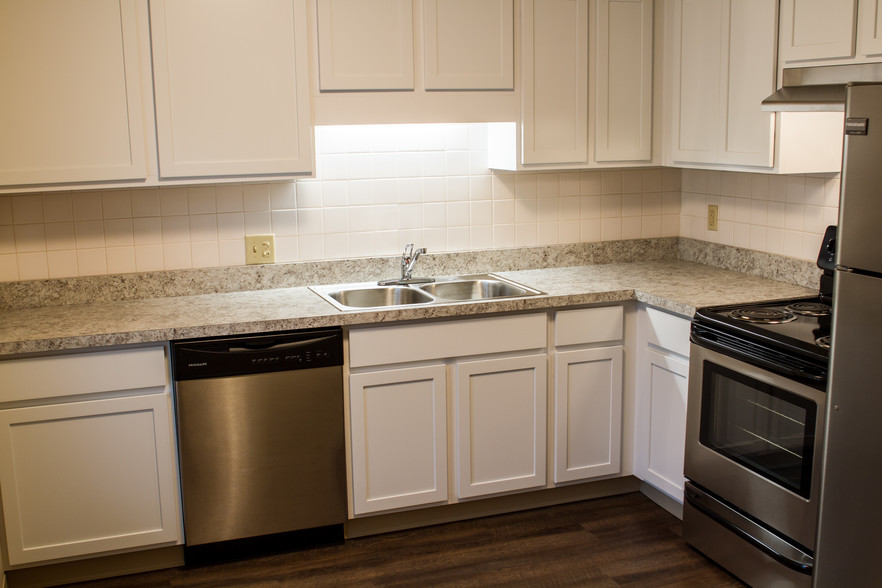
[309,274,545,310]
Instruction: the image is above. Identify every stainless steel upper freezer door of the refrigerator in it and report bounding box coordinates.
[836,85,882,274]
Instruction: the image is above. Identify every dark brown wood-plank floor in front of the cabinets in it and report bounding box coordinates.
[67,493,743,588]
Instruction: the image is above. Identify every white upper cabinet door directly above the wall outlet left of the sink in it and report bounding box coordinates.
[150,0,313,179]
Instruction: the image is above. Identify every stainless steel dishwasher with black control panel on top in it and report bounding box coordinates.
[172,329,346,547]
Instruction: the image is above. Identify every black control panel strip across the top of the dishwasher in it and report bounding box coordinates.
[172,328,343,381]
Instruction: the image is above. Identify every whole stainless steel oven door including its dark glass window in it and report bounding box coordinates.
[684,343,826,551]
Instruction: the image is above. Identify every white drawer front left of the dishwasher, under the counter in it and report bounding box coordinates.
[0,347,168,402]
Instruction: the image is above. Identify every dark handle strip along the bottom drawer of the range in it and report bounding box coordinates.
[686,482,814,576]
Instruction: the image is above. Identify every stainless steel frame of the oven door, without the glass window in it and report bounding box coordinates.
[684,344,826,549]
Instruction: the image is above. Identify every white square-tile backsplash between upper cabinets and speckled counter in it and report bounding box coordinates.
[0,124,839,281]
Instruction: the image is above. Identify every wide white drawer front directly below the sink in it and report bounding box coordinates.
[349,313,547,368]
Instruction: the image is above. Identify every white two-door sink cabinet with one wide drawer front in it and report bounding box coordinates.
[348,313,548,516]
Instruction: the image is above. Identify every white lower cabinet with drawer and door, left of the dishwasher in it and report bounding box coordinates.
[0,347,181,566]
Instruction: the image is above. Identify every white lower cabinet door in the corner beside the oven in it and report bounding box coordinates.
[634,348,689,502]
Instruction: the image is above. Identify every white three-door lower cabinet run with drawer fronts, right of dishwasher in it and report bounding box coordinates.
[348,305,648,517]
